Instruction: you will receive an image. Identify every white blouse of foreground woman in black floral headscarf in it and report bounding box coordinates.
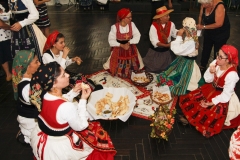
[44,91,88,131]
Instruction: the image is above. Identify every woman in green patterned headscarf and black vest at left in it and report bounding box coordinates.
[12,50,40,143]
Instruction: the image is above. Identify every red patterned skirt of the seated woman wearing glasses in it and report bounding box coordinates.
[179,84,228,137]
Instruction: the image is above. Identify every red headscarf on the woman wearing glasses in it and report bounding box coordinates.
[221,45,238,66]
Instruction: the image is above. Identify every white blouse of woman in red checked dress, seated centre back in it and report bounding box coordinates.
[108,22,141,47]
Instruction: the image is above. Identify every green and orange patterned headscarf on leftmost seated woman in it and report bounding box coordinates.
[12,50,34,100]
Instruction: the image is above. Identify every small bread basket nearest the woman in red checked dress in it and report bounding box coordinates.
[131,71,153,87]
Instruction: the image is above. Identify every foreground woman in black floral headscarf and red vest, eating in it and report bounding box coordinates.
[30,62,116,160]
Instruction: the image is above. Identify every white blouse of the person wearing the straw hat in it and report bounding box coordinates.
[149,22,178,48]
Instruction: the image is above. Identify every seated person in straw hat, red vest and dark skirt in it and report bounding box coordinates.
[143,6,177,73]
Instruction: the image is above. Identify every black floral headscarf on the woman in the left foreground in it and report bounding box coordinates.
[29,62,60,112]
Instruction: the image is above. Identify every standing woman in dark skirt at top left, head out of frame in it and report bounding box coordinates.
[8,0,46,62]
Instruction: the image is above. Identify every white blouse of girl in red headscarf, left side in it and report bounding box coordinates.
[42,49,73,69]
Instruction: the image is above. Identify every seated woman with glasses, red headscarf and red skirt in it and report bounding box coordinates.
[179,45,240,137]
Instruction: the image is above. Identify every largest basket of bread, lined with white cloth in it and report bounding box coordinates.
[87,88,136,121]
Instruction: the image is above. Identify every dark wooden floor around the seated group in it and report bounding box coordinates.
[0,2,240,160]
